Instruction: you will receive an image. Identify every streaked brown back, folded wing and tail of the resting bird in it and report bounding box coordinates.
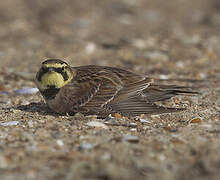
[62,66,191,117]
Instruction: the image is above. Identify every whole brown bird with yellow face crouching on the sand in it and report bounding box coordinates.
[35,59,197,118]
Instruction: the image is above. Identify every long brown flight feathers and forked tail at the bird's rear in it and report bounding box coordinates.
[105,82,197,116]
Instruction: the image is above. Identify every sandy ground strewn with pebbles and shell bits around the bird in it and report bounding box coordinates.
[0,0,220,180]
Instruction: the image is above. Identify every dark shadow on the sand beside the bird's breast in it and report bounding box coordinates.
[13,102,60,116]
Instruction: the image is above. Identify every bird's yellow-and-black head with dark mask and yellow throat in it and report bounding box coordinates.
[36,59,75,91]
